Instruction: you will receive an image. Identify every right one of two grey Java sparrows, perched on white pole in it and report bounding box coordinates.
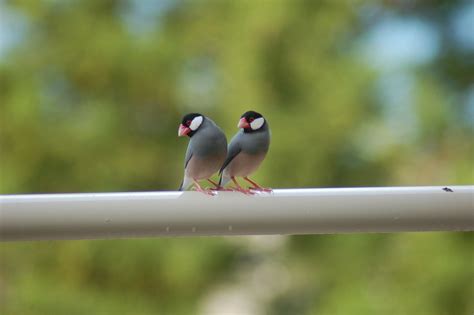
[219,110,272,194]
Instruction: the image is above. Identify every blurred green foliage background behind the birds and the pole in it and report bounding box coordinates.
[0,0,474,315]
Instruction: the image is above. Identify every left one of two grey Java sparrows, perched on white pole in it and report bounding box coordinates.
[178,113,227,195]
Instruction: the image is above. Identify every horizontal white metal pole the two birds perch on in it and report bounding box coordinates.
[0,186,474,241]
